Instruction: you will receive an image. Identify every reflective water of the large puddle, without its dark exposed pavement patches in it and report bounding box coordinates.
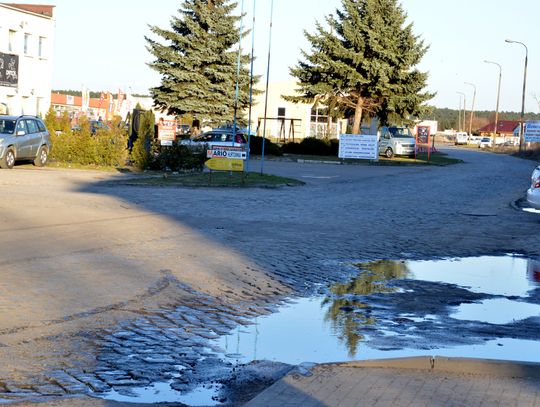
[213,256,540,365]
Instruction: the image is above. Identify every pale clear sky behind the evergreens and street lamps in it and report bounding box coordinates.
[45,0,540,112]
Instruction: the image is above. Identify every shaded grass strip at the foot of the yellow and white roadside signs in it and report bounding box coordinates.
[114,171,304,188]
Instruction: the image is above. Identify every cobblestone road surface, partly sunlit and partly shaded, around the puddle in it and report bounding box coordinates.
[0,146,540,404]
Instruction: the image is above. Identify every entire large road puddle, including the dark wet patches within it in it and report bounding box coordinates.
[214,256,540,365]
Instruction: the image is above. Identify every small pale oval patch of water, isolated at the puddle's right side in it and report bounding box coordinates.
[452,298,540,325]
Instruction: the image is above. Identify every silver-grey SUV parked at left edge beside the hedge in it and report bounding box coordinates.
[0,115,52,168]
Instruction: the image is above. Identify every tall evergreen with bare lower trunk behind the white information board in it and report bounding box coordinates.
[286,0,433,133]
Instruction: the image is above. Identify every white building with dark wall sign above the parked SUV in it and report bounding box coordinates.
[0,3,55,116]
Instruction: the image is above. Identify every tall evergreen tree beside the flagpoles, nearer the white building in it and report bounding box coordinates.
[146,0,249,124]
